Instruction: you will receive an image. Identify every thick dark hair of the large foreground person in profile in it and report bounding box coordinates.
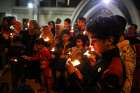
[87,17,120,44]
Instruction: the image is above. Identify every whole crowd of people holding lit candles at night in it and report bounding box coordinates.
[0,15,140,93]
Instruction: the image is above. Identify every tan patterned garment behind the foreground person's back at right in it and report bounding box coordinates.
[118,40,136,93]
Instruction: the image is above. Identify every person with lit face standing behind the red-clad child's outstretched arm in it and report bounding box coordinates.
[20,20,41,81]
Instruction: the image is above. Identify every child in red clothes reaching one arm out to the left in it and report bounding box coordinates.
[23,38,53,93]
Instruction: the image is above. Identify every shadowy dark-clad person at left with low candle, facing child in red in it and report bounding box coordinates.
[8,36,26,90]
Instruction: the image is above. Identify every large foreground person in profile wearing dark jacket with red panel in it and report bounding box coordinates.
[66,17,124,93]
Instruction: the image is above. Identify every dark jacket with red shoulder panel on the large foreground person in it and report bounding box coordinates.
[69,48,124,93]
